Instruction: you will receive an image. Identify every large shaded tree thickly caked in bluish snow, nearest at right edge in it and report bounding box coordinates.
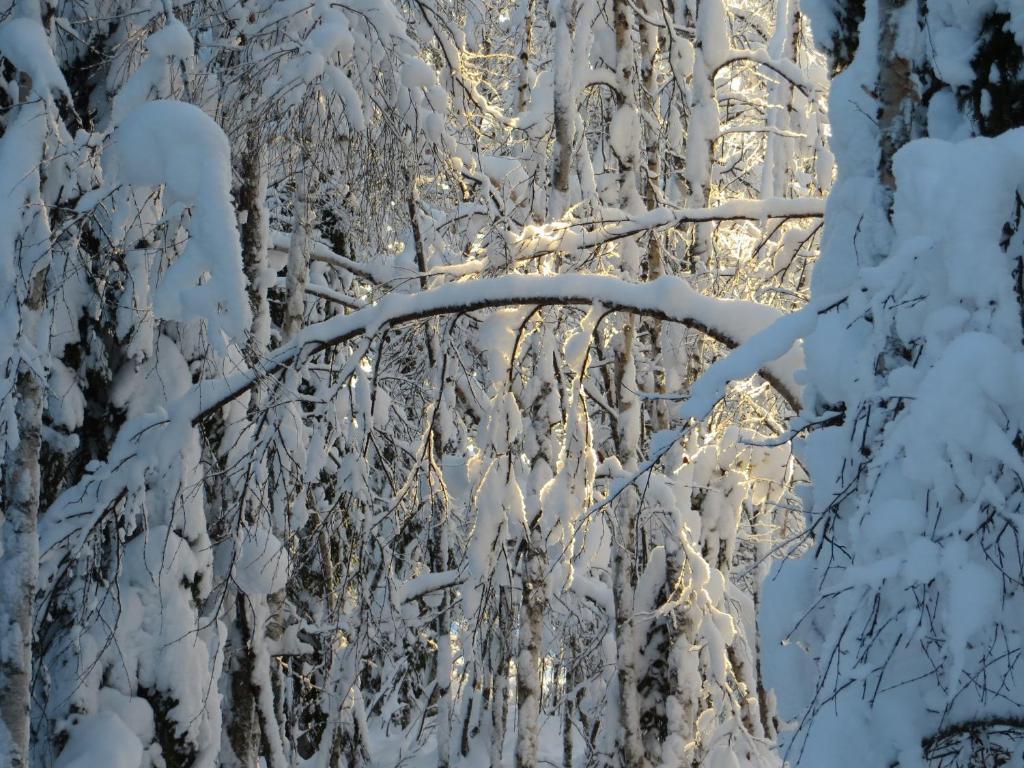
[762,0,1024,766]
